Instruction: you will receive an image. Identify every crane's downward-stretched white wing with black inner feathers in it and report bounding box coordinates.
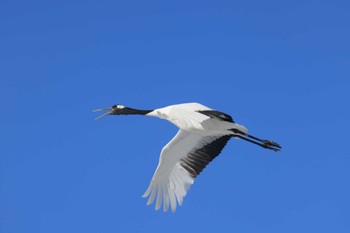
[143,130,231,212]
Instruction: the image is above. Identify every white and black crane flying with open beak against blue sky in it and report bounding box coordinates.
[94,103,281,212]
